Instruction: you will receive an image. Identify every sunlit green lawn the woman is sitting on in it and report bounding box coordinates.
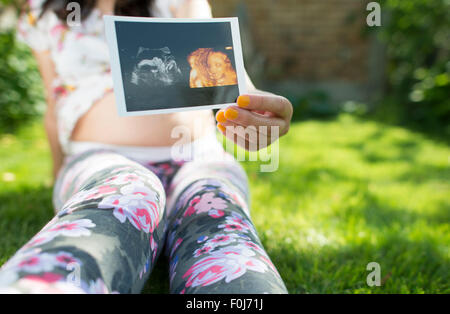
[0,115,450,293]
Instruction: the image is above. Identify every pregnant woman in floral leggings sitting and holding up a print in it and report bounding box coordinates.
[0,0,292,293]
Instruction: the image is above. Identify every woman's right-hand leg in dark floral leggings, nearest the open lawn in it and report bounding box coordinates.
[166,160,287,294]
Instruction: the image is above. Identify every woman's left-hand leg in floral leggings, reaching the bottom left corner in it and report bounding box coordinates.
[0,150,165,293]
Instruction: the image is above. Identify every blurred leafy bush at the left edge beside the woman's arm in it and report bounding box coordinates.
[0,1,44,132]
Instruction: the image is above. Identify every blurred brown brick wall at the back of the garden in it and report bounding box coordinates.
[210,0,376,100]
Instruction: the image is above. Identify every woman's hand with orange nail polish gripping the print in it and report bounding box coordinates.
[216,94,293,151]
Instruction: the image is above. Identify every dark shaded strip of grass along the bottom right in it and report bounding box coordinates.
[269,234,450,293]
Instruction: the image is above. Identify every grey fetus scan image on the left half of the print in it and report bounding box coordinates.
[131,47,182,87]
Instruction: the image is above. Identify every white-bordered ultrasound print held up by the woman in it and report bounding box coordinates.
[105,16,245,116]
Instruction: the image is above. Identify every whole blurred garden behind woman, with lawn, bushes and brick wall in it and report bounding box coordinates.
[0,0,450,293]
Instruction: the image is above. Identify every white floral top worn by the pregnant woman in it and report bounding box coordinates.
[18,0,193,153]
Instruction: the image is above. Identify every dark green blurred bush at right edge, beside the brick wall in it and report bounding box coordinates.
[376,0,450,133]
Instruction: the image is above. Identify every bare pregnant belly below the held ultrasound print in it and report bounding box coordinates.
[71,93,215,146]
